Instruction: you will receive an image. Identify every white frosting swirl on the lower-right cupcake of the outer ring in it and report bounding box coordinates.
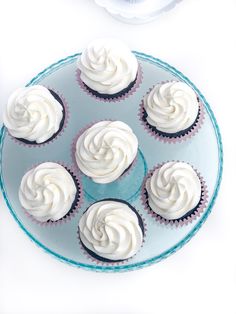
[146,162,201,220]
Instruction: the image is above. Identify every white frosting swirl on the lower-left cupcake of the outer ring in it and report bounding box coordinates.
[19,162,77,222]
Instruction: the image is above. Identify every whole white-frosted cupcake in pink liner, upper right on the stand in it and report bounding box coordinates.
[139,81,204,143]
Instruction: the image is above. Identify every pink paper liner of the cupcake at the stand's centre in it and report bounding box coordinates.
[71,119,138,184]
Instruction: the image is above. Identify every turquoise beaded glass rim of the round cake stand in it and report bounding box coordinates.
[0,51,223,272]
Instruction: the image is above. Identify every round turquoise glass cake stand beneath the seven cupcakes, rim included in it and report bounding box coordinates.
[0,52,223,272]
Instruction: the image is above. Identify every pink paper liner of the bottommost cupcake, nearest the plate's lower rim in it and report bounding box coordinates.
[77,214,147,266]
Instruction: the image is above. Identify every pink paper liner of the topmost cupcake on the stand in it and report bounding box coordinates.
[76,64,143,102]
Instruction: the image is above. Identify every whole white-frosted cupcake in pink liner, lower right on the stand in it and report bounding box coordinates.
[142,161,207,226]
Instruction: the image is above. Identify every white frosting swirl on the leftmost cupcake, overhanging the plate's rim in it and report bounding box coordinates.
[3,85,63,143]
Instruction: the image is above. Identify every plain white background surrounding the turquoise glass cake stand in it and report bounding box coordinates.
[0,0,236,314]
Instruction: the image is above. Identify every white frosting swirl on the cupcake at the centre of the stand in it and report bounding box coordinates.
[75,121,138,183]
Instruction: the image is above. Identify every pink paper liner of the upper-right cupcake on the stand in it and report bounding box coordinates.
[138,81,205,144]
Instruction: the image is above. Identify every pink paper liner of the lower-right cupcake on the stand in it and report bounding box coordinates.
[141,160,208,227]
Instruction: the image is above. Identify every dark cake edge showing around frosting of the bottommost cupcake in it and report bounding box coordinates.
[77,198,145,263]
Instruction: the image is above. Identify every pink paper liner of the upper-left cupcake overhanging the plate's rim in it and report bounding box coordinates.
[7,86,70,148]
